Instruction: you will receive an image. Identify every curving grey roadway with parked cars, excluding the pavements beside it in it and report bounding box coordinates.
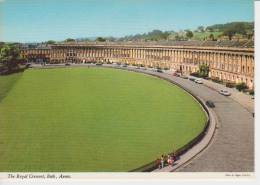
[31,65,254,172]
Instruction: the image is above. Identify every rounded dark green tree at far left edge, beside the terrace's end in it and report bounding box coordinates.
[0,44,23,71]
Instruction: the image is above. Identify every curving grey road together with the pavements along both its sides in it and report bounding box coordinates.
[31,64,254,172]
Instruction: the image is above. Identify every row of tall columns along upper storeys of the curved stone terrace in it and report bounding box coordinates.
[23,47,254,74]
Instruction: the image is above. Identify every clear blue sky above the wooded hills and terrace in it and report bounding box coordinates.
[0,0,254,42]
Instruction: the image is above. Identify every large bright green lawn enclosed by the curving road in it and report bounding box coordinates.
[0,68,206,172]
